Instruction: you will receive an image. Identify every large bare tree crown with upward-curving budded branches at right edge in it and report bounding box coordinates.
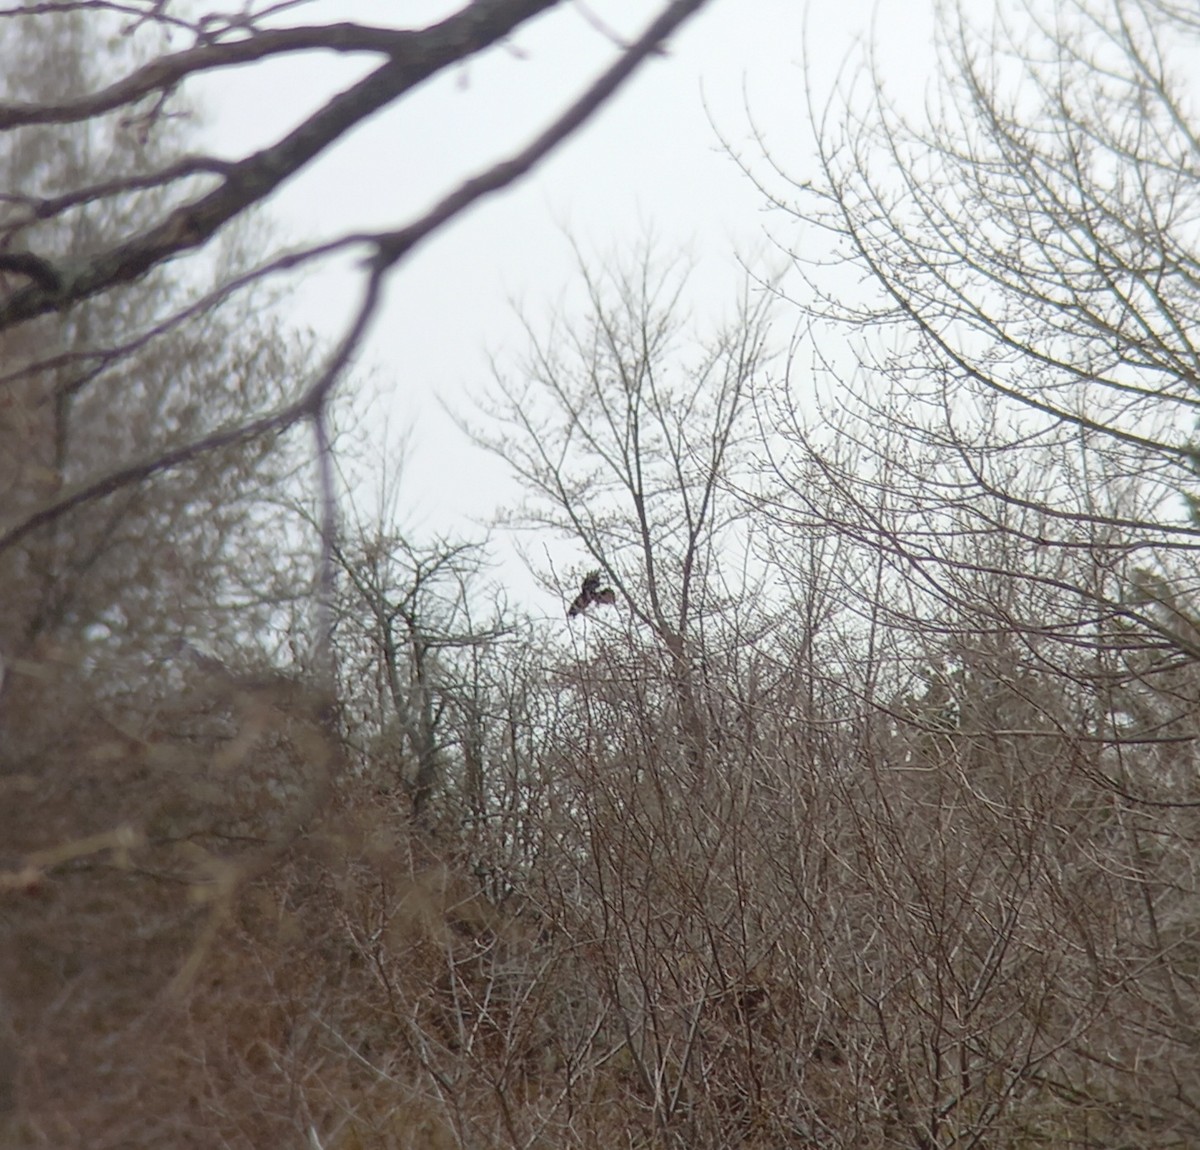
[753,2,1198,681]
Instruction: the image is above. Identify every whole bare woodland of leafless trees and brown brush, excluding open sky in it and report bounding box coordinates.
[0,0,1200,1150]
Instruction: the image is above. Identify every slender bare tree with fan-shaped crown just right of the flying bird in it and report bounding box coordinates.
[472,240,768,765]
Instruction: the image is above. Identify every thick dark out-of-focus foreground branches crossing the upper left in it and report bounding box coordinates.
[0,0,702,633]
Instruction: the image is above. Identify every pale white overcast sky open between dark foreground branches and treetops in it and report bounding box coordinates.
[200,0,931,612]
